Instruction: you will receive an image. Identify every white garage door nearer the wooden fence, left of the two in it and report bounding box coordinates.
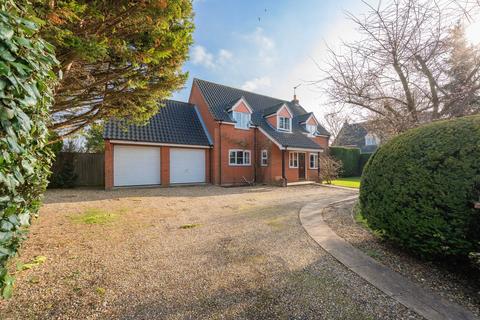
[113,145,160,187]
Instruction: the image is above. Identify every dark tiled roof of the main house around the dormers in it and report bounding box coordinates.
[193,79,330,149]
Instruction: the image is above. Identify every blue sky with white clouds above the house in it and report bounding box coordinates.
[173,0,480,122]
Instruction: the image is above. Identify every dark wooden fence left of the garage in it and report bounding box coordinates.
[51,152,105,187]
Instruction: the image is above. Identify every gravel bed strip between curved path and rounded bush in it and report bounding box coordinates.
[323,201,480,316]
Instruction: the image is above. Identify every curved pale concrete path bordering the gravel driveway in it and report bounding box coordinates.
[300,196,478,320]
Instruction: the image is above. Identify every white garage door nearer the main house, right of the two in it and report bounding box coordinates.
[170,149,205,183]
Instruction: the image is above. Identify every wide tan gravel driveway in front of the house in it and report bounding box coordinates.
[0,186,419,319]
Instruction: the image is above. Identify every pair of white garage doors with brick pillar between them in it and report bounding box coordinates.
[111,144,209,187]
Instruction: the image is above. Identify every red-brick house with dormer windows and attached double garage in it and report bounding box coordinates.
[104,79,330,189]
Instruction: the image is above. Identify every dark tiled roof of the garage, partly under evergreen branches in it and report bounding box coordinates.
[104,100,211,146]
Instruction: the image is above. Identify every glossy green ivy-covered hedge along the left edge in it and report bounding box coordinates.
[0,0,57,298]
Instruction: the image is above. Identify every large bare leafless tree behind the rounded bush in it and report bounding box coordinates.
[324,0,480,134]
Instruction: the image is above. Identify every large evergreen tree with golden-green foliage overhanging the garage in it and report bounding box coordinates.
[31,0,194,136]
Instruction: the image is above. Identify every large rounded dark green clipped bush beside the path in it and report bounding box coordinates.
[360,116,480,258]
